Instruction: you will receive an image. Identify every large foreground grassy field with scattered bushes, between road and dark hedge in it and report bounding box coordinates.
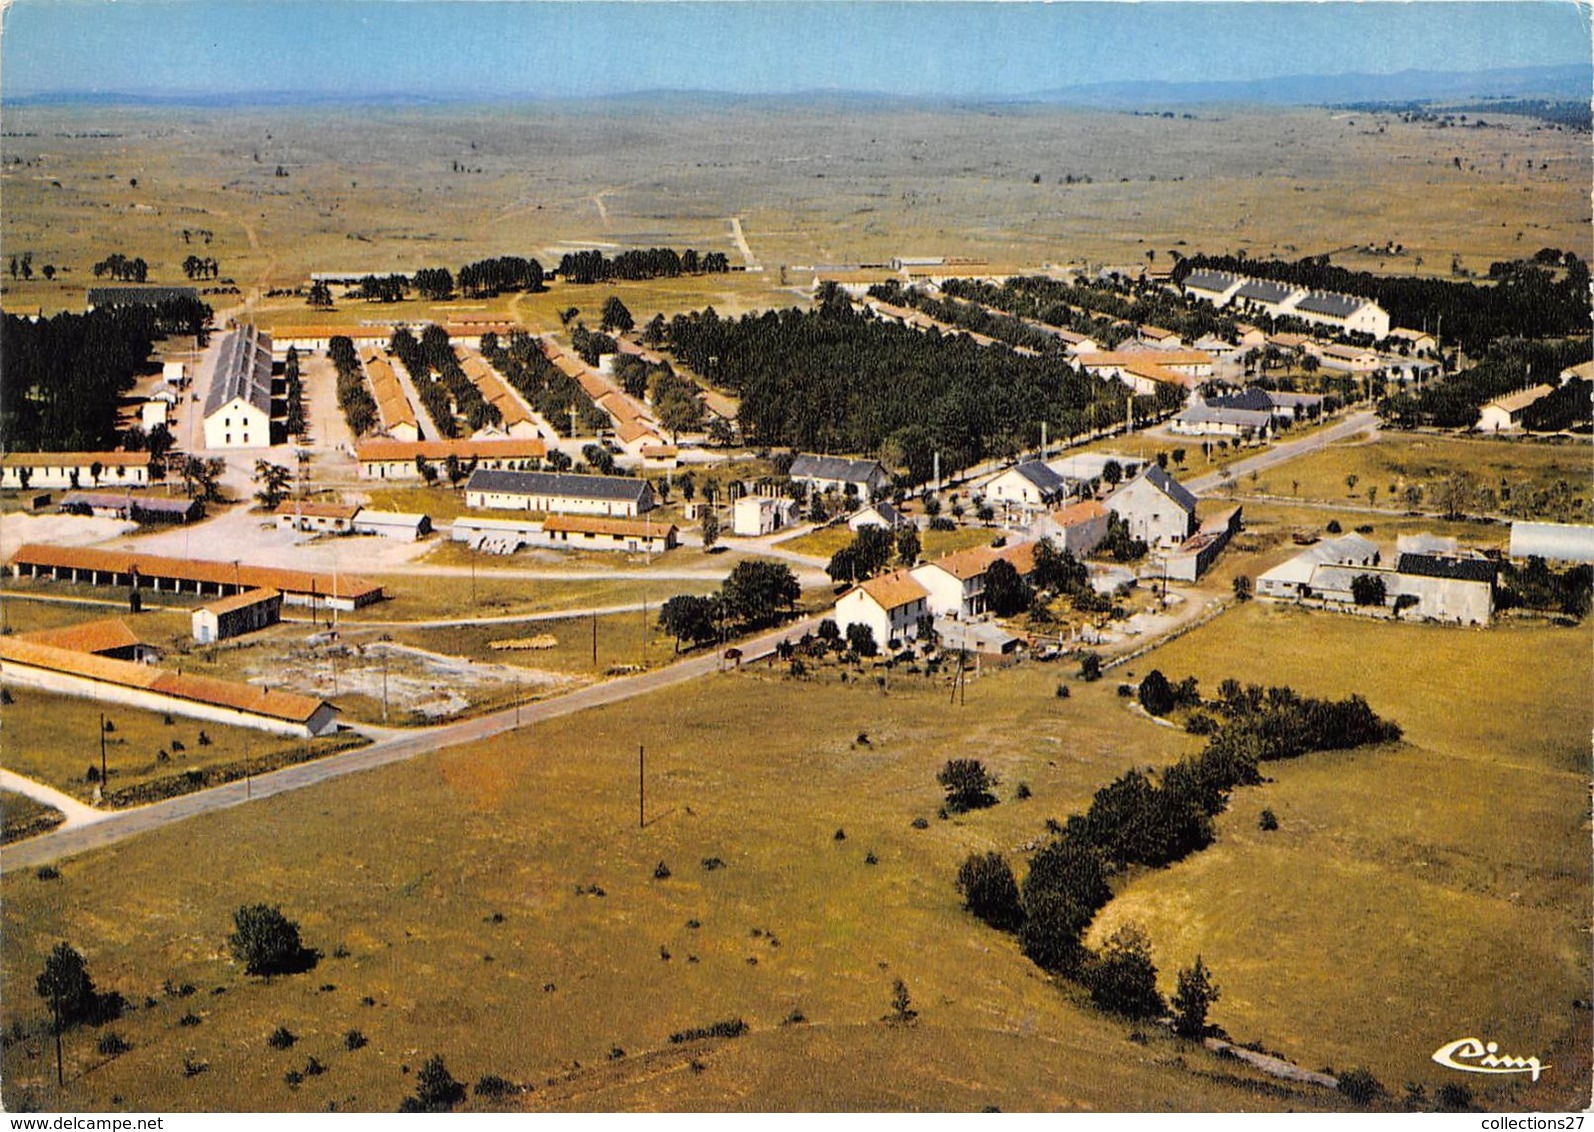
[0,666,1358,1110]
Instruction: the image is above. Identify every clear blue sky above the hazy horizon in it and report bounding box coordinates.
[0,0,1589,97]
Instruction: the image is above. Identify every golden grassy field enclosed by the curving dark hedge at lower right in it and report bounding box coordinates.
[1093,603,1594,1108]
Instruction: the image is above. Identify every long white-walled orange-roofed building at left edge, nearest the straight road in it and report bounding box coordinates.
[0,638,336,738]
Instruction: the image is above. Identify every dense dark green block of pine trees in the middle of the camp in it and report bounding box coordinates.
[665,285,1124,483]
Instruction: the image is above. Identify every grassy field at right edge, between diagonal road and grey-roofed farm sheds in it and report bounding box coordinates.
[1240,434,1594,523]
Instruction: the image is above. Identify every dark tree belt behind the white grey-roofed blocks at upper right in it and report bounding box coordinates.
[1173,249,1594,357]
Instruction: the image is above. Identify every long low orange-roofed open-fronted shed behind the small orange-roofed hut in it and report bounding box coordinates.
[11,542,383,609]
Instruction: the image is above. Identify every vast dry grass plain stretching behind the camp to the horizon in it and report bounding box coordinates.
[0,97,1588,328]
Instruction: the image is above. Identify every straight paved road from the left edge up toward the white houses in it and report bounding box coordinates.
[0,617,819,872]
